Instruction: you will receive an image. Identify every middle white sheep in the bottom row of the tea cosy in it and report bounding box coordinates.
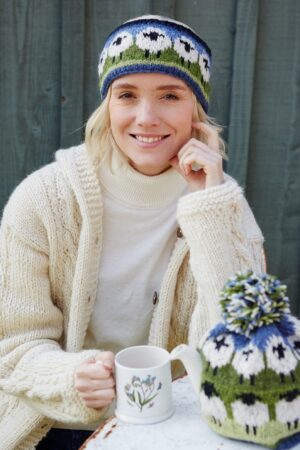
[231,392,269,435]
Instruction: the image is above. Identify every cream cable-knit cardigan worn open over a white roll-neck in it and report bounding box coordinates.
[0,145,263,450]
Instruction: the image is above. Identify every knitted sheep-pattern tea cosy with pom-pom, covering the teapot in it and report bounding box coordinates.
[198,272,300,450]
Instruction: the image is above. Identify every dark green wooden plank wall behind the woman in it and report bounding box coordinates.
[0,0,300,313]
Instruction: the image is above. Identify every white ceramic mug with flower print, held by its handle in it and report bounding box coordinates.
[115,345,174,424]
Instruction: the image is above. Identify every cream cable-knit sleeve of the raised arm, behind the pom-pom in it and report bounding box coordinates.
[177,176,264,346]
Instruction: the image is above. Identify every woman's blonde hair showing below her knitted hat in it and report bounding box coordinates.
[85,87,227,165]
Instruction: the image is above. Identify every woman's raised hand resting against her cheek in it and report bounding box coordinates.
[170,122,224,191]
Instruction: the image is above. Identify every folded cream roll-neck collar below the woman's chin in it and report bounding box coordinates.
[100,152,187,208]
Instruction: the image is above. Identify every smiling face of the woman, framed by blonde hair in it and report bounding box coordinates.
[109,73,194,175]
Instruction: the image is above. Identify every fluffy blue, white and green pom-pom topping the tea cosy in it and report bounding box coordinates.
[220,271,290,336]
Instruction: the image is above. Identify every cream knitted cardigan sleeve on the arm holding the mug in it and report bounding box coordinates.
[0,171,106,423]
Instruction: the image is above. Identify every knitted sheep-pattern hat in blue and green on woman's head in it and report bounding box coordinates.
[98,16,211,112]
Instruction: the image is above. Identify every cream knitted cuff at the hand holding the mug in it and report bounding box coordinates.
[1,350,106,423]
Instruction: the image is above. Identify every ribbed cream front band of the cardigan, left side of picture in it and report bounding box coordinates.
[56,144,103,352]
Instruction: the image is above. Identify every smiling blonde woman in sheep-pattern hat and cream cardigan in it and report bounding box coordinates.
[0,16,263,450]
